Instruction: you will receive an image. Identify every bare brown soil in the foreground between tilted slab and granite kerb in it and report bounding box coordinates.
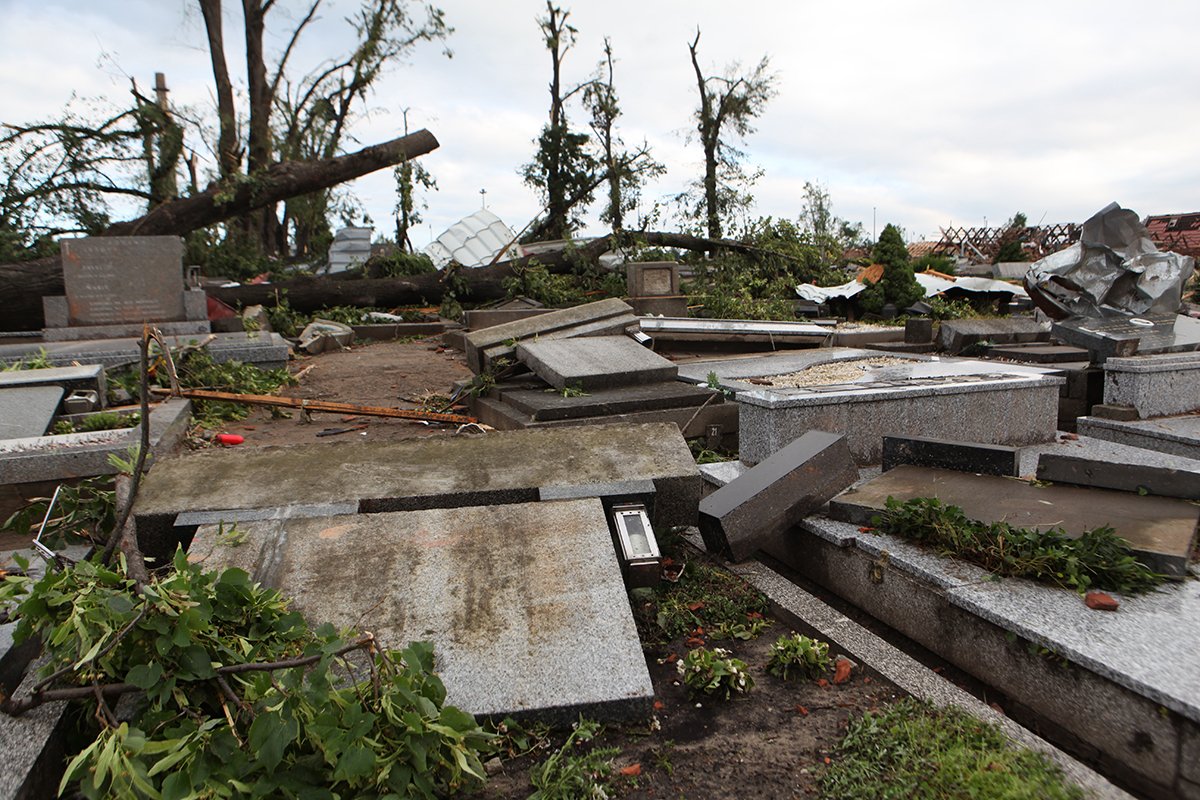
[479,621,904,800]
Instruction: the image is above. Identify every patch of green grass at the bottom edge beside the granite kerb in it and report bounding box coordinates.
[821,699,1084,800]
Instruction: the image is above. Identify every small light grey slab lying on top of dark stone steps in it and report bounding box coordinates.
[516,336,678,391]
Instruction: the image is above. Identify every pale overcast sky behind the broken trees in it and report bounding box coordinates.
[0,0,1200,246]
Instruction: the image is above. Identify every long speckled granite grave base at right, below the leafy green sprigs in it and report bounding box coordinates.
[772,513,1200,796]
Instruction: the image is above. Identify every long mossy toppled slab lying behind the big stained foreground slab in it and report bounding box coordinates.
[133,423,701,557]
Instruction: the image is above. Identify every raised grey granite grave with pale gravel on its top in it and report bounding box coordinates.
[680,348,1064,464]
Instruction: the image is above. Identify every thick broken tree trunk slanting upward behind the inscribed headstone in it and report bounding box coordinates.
[0,131,438,331]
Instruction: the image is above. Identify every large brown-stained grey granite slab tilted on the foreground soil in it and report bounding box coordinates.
[188,499,654,723]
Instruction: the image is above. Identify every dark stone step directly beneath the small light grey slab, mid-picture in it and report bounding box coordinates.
[499,380,724,422]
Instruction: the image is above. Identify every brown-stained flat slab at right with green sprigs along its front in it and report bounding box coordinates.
[829,465,1200,577]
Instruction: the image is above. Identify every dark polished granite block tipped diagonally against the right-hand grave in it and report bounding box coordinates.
[700,431,858,561]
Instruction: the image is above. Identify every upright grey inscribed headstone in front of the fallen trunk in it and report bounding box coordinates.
[43,236,209,341]
